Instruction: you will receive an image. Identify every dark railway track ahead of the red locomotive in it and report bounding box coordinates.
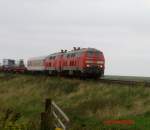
[100,78,150,87]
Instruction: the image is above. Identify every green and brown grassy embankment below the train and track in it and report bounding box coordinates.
[0,74,150,130]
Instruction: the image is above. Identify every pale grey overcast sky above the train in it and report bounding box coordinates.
[0,0,150,76]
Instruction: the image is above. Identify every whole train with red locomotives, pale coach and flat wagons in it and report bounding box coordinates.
[0,47,105,78]
